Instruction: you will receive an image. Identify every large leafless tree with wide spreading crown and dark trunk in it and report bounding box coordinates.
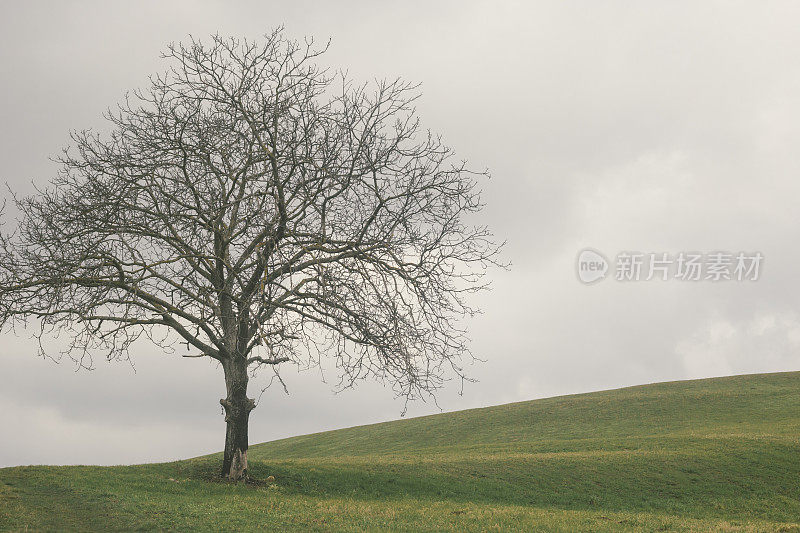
[0,29,498,480]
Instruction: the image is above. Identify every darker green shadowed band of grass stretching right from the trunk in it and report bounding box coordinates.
[176,436,800,521]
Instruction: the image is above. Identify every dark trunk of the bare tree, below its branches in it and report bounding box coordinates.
[219,358,256,481]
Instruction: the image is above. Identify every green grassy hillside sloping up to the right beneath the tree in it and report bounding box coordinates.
[0,372,800,532]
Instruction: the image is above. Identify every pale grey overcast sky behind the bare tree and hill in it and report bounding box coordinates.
[0,1,800,466]
